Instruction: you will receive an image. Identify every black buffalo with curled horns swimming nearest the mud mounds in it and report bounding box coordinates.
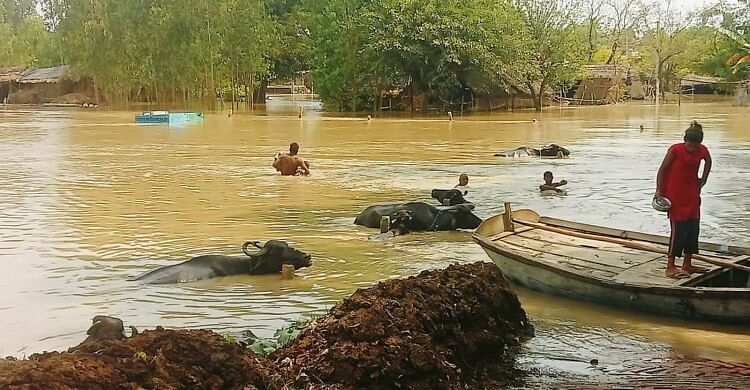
[132,240,312,284]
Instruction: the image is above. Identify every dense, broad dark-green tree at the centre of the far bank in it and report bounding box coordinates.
[309,0,519,111]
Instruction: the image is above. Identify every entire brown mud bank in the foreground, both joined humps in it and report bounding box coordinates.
[0,263,533,390]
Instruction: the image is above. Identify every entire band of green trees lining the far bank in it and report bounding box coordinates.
[5,0,750,108]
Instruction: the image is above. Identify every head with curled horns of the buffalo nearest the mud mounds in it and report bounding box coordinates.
[242,240,312,274]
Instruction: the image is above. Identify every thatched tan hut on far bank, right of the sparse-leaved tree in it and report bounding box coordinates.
[570,64,644,105]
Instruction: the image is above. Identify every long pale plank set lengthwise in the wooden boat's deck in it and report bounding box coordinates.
[503,235,636,272]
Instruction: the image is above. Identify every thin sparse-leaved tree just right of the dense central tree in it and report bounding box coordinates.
[514,0,586,111]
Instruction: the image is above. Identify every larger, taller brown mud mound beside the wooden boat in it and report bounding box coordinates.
[271,263,533,389]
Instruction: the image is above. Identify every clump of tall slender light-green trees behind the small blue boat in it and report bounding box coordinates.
[38,0,276,106]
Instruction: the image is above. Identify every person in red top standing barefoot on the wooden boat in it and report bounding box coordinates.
[655,121,711,279]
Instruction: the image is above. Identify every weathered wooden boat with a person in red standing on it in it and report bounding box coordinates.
[473,204,750,325]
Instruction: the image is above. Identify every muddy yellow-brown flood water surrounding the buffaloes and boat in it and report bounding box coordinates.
[0,99,750,362]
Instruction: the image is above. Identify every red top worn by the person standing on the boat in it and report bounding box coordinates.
[663,143,708,221]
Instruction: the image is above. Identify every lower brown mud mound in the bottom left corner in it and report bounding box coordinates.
[0,329,278,390]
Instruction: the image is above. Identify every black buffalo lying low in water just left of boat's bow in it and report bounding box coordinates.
[354,202,482,231]
